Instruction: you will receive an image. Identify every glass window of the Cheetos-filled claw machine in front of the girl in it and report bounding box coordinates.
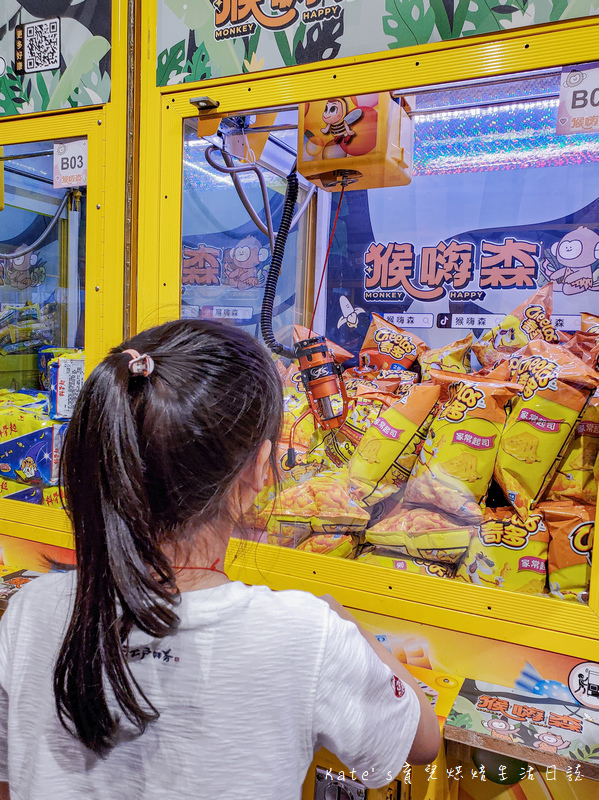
[183,68,599,604]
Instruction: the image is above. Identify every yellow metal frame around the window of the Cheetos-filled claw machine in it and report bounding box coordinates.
[137,9,599,660]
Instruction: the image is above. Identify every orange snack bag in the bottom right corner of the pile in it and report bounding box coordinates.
[539,503,595,603]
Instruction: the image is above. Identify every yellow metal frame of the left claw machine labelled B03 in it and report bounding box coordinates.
[0,2,127,548]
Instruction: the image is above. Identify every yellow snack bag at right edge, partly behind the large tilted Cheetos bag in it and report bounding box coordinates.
[545,390,599,505]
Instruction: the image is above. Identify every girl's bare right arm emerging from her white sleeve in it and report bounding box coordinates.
[322,595,441,768]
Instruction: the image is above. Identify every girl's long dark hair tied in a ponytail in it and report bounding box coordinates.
[54,320,282,756]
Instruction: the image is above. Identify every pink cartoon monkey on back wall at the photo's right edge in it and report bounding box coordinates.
[541,225,599,294]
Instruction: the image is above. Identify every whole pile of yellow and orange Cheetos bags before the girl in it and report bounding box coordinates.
[256,296,599,602]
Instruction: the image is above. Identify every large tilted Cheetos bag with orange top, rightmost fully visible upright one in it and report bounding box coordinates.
[495,341,599,519]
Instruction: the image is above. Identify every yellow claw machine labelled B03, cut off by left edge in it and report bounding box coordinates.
[0,0,128,588]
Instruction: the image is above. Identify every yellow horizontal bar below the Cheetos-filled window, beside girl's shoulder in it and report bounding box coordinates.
[225,540,599,660]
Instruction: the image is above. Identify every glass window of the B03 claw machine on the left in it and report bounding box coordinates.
[0,140,85,507]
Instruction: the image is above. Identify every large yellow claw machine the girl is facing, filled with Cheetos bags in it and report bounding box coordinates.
[137,0,599,800]
